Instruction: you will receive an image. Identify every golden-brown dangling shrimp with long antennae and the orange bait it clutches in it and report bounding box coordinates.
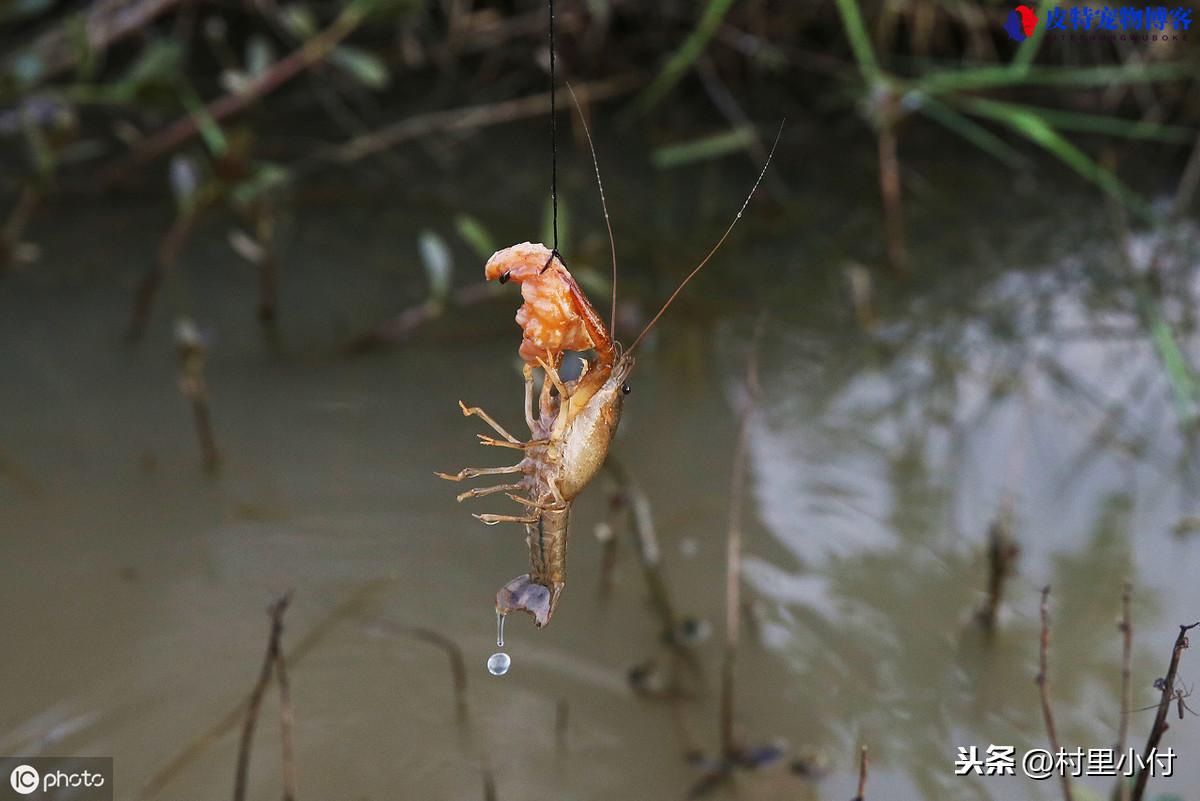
[436,120,782,628]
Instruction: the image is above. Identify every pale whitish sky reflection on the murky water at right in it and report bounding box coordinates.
[746,215,1200,797]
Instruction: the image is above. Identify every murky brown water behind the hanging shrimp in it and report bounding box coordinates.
[0,122,1200,801]
